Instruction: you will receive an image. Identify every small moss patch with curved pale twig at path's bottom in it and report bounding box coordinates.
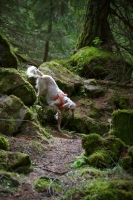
[34,178,62,195]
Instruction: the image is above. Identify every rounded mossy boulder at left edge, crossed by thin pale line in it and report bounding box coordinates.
[0,95,32,136]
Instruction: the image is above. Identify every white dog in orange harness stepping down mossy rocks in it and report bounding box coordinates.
[27,66,76,131]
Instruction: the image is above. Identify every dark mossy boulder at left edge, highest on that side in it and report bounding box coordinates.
[0,34,18,69]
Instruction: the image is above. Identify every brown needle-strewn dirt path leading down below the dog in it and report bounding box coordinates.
[0,131,83,200]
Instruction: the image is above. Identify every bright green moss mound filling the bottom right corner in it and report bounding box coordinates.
[84,179,133,200]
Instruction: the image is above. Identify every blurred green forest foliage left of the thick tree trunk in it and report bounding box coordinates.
[0,0,87,64]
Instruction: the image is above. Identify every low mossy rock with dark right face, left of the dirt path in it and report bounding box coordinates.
[0,150,31,171]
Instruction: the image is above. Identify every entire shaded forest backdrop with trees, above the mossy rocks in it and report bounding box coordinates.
[0,0,133,68]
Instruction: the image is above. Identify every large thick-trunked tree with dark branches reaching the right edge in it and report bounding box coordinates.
[76,0,133,62]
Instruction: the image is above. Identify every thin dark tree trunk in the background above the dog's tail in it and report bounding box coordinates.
[43,0,53,62]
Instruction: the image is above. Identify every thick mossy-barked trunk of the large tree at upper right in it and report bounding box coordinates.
[76,0,114,50]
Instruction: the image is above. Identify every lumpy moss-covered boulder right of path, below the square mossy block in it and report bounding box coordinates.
[82,133,126,168]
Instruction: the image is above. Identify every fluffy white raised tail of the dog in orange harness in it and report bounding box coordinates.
[26,66,43,78]
